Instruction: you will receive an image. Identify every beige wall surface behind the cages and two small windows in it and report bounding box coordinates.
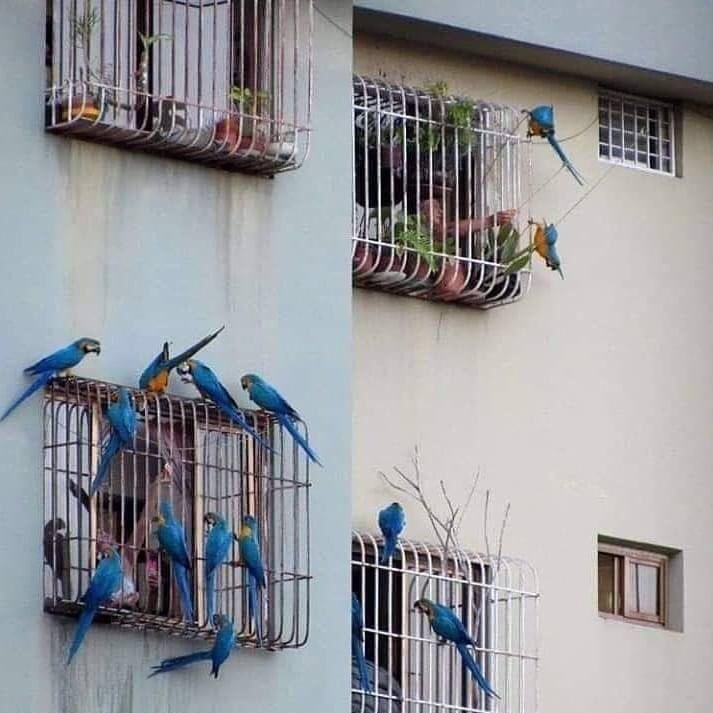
[353,30,713,713]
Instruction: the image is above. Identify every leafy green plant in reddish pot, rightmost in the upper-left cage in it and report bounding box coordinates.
[214,87,270,152]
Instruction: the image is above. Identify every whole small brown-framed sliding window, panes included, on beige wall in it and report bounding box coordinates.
[597,538,673,626]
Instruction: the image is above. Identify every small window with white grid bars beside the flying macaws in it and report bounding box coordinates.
[599,91,676,176]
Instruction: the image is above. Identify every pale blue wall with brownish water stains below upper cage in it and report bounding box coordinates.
[0,0,352,713]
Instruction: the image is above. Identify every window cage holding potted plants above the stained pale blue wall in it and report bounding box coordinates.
[46,0,313,175]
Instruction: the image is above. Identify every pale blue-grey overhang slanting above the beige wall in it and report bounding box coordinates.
[354,0,713,82]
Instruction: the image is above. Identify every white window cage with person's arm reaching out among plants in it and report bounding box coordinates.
[352,76,530,308]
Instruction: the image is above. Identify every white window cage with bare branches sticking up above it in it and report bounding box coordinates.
[351,532,539,713]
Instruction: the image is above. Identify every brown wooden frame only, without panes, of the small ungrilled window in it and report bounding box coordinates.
[597,542,670,627]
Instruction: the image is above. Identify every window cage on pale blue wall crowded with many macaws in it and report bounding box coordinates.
[43,377,310,649]
